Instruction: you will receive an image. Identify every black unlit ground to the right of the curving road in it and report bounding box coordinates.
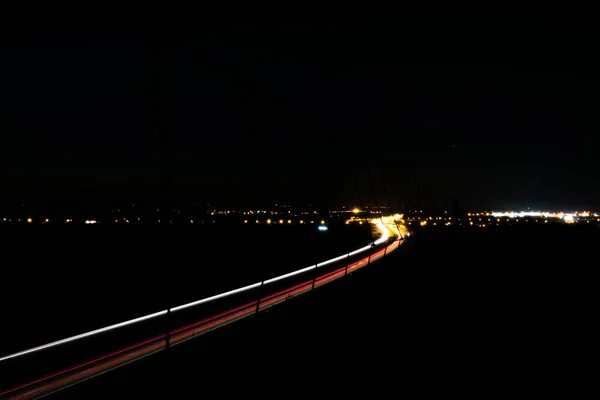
[37,226,600,398]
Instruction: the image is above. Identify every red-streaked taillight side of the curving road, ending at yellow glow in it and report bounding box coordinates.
[0,217,403,399]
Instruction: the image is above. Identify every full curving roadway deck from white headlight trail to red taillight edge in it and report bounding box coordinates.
[0,216,408,399]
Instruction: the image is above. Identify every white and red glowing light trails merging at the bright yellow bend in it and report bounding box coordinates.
[0,217,403,399]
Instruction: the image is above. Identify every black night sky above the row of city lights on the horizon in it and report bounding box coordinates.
[0,19,600,209]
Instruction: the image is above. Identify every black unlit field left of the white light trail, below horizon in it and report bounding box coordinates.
[0,224,370,355]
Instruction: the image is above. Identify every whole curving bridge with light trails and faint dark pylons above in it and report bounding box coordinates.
[0,29,457,399]
